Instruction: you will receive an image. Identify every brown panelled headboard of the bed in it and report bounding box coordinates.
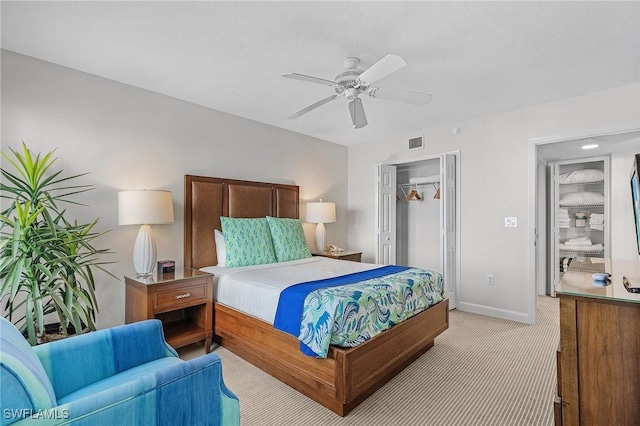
[184,175,299,269]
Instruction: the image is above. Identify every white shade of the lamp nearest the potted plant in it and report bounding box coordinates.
[118,190,173,225]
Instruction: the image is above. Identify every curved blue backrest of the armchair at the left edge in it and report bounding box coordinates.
[0,317,56,425]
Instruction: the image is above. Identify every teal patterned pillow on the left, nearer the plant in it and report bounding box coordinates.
[220,216,277,268]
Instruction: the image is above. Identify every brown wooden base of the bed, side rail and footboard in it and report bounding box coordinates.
[214,299,449,416]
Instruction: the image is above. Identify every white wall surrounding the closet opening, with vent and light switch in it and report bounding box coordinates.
[348,84,640,321]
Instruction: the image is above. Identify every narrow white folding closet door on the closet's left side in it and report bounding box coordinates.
[376,165,396,265]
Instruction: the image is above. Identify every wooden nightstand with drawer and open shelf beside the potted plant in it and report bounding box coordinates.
[124,268,213,353]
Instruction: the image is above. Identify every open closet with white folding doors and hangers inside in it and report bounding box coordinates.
[376,151,460,309]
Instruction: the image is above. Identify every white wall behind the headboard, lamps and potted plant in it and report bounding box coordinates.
[1,51,347,327]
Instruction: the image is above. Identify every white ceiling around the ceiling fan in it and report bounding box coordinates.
[0,1,640,145]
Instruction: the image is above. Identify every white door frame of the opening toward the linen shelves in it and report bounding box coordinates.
[526,125,640,324]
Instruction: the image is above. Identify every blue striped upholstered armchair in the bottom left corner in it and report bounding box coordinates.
[0,318,240,426]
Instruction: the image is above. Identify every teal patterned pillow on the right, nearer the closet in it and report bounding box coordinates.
[267,216,311,262]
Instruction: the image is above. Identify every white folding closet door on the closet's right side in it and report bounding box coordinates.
[440,154,458,309]
